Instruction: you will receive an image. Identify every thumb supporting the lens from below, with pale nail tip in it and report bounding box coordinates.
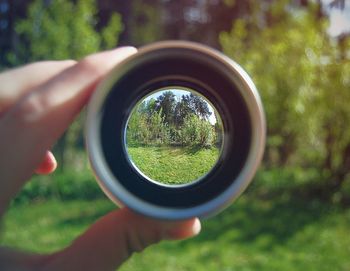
[48,209,200,271]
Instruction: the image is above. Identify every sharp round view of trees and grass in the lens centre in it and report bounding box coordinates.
[126,89,222,184]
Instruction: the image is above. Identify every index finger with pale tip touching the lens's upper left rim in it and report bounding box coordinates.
[0,47,136,215]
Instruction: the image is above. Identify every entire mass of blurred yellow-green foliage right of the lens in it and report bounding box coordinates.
[220,6,350,191]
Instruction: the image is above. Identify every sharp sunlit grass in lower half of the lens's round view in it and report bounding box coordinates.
[128,146,219,184]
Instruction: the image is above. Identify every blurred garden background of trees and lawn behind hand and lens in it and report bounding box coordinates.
[0,0,350,271]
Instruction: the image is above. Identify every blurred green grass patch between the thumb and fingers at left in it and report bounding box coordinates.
[1,199,115,252]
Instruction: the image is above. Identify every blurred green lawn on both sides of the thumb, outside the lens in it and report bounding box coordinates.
[1,197,350,271]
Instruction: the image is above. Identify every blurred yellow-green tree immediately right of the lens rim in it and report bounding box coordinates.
[221,6,320,166]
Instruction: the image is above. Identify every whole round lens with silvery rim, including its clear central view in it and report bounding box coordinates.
[86,41,265,219]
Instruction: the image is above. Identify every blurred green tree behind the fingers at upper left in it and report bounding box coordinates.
[8,0,123,169]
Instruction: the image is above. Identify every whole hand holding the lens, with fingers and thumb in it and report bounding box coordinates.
[0,47,200,270]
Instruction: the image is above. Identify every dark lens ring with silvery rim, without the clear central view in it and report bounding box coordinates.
[86,41,266,220]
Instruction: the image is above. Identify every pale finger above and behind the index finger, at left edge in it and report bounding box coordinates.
[0,60,76,115]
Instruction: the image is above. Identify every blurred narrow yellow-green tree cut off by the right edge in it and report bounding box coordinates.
[308,38,350,193]
